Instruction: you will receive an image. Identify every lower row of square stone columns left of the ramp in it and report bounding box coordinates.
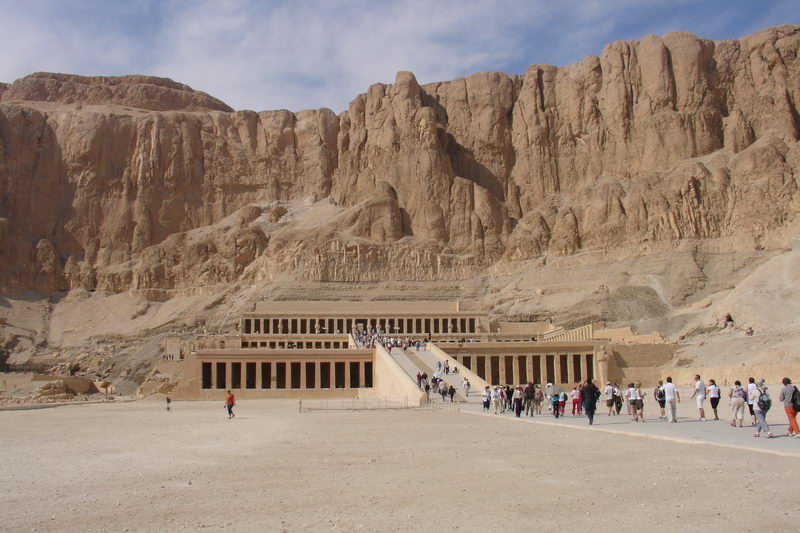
[200,360,372,390]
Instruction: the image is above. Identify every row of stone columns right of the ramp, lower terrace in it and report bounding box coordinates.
[456,354,596,385]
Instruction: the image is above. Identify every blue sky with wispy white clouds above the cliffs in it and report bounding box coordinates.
[0,0,800,112]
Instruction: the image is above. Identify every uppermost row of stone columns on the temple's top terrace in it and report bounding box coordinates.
[242,317,477,335]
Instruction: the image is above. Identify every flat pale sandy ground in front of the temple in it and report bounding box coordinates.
[0,401,800,532]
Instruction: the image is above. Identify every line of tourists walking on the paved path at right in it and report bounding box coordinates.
[481,376,800,438]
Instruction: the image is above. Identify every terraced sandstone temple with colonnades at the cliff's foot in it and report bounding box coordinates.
[152,301,672,403]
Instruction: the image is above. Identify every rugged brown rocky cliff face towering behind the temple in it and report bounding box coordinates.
[0,26,800,293]
